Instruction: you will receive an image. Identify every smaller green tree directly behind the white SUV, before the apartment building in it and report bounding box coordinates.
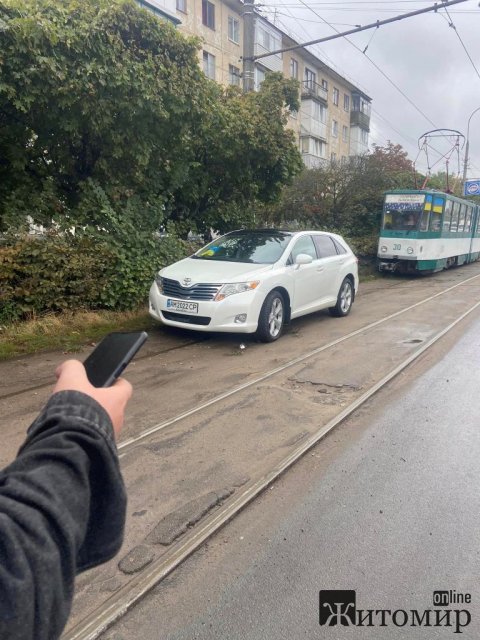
[163,73,303,232]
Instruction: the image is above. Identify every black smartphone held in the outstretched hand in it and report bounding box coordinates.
[83,331,148,387]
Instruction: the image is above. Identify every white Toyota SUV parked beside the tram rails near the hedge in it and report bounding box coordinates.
[149,229,358,342]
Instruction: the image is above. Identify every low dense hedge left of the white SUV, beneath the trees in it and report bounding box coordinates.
[0,233,192,324]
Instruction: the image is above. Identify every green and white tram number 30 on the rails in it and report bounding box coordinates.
[378,190,480,273]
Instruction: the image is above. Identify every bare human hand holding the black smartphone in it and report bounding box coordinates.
[53,360,132,439]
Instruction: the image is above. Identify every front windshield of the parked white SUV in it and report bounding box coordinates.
[193,231,291,264]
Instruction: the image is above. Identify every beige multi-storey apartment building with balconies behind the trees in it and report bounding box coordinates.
[137,0,371,168]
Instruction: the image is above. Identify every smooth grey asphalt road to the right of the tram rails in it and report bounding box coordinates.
[104,308,480,640]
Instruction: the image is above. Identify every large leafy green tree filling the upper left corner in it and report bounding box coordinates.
[0,0,210,234]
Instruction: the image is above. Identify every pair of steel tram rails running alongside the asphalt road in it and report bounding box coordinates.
[64,276,480,640]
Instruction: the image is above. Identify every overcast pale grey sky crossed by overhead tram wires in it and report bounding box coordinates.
[256,0,480,178]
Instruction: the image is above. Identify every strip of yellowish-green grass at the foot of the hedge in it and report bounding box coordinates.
[0,309,154,360]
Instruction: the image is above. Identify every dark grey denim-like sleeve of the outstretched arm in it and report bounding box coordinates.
[0,391,126,640]
